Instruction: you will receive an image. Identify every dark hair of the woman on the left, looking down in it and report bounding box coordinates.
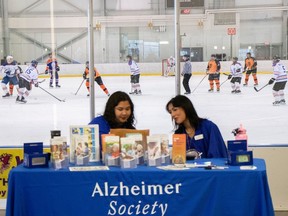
[103,91,136,129]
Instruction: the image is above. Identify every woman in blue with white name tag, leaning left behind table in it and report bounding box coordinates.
[166,95,227,158]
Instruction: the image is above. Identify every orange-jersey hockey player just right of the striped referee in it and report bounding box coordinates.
[206,54,221,92]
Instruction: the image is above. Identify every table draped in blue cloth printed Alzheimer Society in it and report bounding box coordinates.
[6,159,274,216]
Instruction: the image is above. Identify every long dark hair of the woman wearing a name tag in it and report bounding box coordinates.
[166,95,203,130]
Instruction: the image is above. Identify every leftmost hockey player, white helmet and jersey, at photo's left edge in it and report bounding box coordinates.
[1,56,20,98]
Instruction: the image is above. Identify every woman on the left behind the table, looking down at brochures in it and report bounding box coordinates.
[89,91,136,150]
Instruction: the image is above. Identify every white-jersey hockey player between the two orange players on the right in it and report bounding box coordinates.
[228,57,243,94]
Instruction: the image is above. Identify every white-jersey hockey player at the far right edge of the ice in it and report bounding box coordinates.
[268,56,287,106]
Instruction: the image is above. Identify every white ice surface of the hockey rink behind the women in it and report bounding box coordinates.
[0,75,288,146]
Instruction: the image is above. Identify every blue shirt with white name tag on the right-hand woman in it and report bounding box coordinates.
[175,119,227,158]
